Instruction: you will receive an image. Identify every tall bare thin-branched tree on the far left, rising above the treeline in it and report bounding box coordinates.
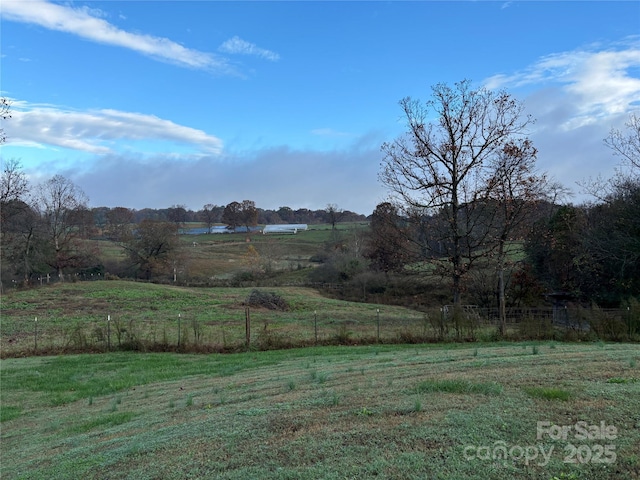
[36,175,88,279]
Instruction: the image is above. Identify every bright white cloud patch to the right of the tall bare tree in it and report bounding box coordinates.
[484,37,640,195]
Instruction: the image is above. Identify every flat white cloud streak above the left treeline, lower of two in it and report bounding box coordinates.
[7,101,222,155]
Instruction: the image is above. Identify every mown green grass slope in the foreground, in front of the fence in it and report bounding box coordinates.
[0,343,640,480]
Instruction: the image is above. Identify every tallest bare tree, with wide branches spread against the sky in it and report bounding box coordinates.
[380,80,532,305]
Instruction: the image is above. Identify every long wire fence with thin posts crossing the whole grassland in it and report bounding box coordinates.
[0,306,640,357]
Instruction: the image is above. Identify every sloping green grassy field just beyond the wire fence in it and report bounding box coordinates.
[0,280,430,357]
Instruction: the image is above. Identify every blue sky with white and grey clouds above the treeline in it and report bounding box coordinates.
[0,0,640,215]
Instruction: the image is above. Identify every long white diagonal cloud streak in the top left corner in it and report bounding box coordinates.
[2,0,233,73]
